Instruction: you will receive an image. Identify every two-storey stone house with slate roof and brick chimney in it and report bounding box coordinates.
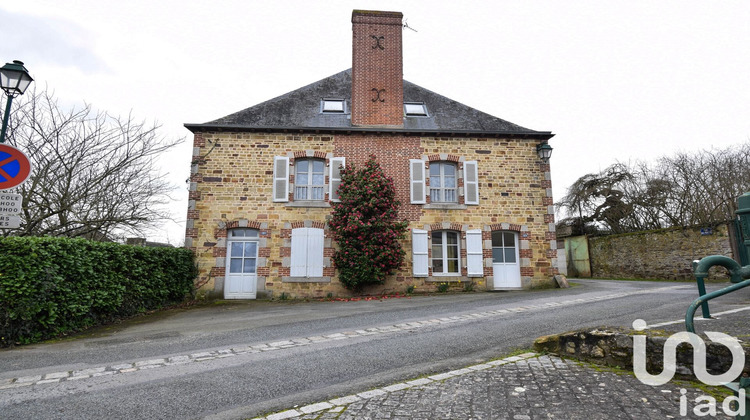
[185,10,557,299]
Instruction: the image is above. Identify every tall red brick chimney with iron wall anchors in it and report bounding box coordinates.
[352,10,404,127]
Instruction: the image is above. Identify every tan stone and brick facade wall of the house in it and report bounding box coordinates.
[186,132,557,298]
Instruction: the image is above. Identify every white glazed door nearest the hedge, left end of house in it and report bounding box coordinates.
[224,229,258,299]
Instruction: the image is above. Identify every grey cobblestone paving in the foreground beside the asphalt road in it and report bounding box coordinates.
[266,354,731,420]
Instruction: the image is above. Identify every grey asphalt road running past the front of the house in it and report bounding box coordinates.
[0,280,750,419]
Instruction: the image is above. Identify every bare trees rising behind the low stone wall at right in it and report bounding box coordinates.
[557,143,750,234]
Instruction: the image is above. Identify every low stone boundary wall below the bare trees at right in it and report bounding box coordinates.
[589,225,733,280]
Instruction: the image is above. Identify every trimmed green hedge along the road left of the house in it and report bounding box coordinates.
[0,237,196,347]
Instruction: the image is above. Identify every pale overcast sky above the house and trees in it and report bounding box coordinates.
[0,0,750,244]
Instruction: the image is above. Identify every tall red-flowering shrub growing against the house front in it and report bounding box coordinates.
[328,156,408,290]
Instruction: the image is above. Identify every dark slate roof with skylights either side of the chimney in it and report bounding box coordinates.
[185,69,553,139]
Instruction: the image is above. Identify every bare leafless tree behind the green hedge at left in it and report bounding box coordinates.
[5,91,184,239]
